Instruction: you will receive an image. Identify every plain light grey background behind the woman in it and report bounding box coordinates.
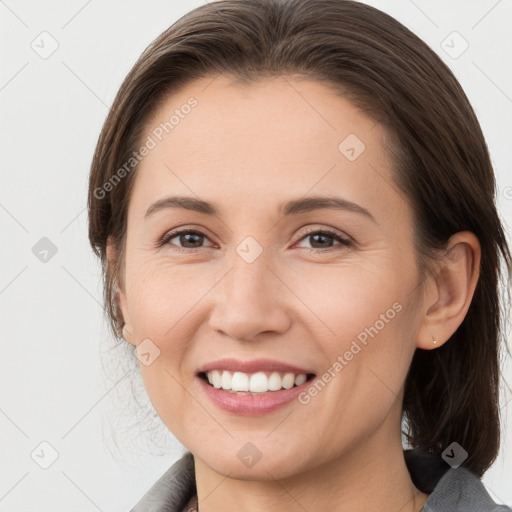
[0,0,512,512]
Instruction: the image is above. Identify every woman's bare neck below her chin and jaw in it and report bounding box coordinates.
[194,420,428,512]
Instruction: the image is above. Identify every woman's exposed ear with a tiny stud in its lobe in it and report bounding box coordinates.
[416,231,481,350]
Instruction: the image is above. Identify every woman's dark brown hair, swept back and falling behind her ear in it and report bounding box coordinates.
[88,0,512,476]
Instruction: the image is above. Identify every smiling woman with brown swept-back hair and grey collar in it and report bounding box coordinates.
[89,0,512,512]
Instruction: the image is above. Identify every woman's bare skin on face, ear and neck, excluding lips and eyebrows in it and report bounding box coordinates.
[108,76,480,512]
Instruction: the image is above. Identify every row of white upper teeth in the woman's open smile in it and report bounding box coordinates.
[206,370,307,393]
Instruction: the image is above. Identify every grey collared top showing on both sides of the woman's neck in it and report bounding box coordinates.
[130,450,512,512]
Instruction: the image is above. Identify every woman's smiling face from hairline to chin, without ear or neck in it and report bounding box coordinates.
[116,77,428,480]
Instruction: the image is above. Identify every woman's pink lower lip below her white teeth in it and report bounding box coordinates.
[196,376,313,416]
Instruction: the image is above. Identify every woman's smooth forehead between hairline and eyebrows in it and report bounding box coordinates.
[133,76,403,224]
